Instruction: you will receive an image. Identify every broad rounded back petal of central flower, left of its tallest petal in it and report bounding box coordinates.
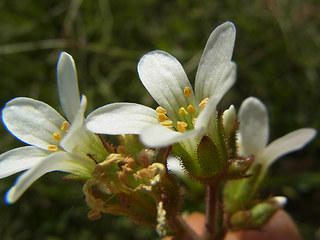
[138,51,194,121]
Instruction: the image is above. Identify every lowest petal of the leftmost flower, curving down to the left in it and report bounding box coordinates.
[6,152,95,203]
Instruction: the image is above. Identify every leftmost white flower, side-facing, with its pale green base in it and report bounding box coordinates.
[0,52,108,203]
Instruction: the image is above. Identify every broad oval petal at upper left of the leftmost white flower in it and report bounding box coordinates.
[2,98,65,149]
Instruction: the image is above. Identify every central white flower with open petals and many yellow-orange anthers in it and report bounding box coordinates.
[86,22,236,147]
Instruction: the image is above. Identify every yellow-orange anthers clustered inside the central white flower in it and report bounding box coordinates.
[156,87,209,132]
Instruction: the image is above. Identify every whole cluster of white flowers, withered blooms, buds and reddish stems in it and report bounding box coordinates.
[0,22,316,239]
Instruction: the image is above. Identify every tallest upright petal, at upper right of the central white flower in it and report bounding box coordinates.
[195,22,236,100]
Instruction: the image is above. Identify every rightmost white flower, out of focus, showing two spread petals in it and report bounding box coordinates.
[239,97,316,170]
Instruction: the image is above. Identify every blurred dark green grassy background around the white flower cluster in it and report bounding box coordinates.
[0,0,320,240]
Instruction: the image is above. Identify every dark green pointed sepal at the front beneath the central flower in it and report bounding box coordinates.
[197,136,227,178]
